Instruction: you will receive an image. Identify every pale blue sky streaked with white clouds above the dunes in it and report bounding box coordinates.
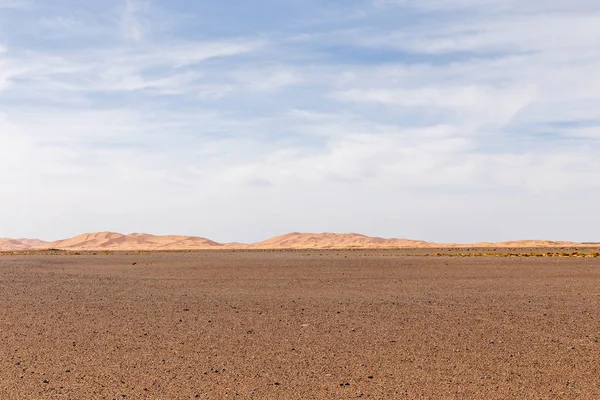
[0,0,600,243]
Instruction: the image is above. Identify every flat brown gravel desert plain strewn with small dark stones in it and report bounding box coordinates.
[0,250,600,400]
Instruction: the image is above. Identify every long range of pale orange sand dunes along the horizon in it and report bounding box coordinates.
[0,232,592,251]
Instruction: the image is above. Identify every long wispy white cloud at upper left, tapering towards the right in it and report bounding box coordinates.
[0,40,262,97]
